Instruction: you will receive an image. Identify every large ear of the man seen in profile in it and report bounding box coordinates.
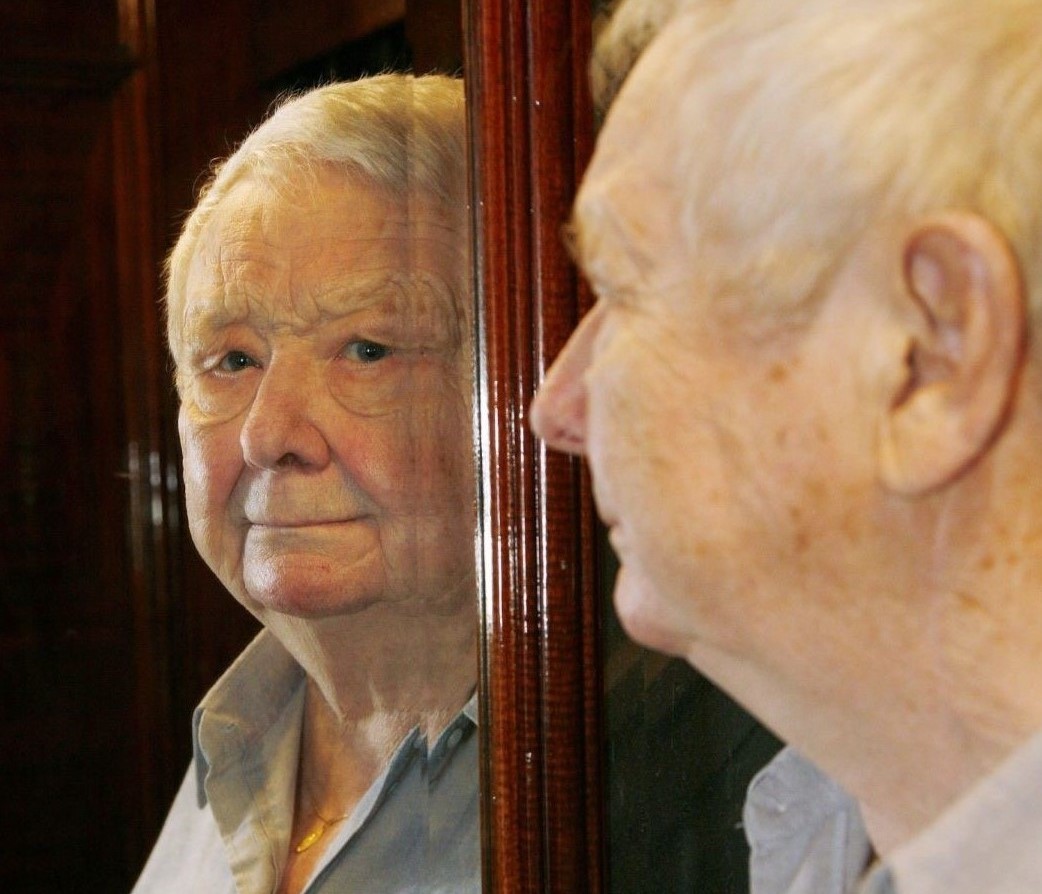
[879,213,1026,494]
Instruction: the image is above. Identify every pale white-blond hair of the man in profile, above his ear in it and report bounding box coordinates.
[660,0,1042,314]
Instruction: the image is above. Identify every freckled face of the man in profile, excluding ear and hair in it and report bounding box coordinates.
[532,22,871,657]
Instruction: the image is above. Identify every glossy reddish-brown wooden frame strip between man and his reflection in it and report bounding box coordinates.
[464,0,603,894]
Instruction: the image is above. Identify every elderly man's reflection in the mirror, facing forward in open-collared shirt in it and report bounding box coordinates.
[134,75,480,894]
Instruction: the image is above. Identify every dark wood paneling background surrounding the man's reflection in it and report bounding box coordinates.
[0,0,472,892]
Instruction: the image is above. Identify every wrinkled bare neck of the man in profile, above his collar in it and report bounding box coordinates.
[689,477,1042,856]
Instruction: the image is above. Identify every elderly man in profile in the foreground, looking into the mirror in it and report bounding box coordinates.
[531,0,1042,894]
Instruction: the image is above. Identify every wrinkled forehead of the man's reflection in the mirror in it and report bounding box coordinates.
[181,165,466,336]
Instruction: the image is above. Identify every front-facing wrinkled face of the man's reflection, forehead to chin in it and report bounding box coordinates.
[172,170,473,619]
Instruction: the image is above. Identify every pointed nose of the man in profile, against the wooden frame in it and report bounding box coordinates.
[529,305,600,453]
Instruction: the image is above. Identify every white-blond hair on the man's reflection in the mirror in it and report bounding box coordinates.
[167,74,467,356]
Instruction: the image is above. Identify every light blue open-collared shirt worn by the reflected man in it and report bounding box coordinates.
[133,630,481,894]
